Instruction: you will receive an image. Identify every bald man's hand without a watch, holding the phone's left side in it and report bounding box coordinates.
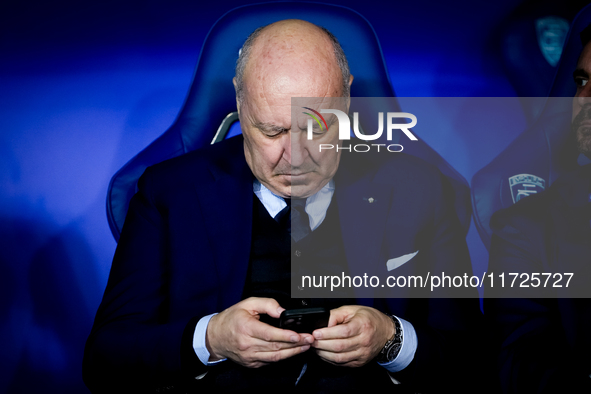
[206,297,314,368]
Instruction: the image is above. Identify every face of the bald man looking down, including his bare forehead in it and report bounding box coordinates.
[238,22,352,198]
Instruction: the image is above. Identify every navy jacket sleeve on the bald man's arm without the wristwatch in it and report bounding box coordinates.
[83,169,206,393]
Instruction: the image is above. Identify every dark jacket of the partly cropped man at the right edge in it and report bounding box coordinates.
[484,165,591,393]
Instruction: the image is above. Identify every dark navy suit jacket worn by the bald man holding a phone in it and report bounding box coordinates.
[84,136,480,391]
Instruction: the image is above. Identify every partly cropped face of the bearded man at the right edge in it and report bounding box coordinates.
[572,43,591,158]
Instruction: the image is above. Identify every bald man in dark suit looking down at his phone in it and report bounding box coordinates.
[84,20,479,392]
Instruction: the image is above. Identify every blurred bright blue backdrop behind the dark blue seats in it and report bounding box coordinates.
[0,0,572,393]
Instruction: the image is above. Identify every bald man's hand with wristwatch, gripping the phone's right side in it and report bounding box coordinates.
[312,305,396,367]
